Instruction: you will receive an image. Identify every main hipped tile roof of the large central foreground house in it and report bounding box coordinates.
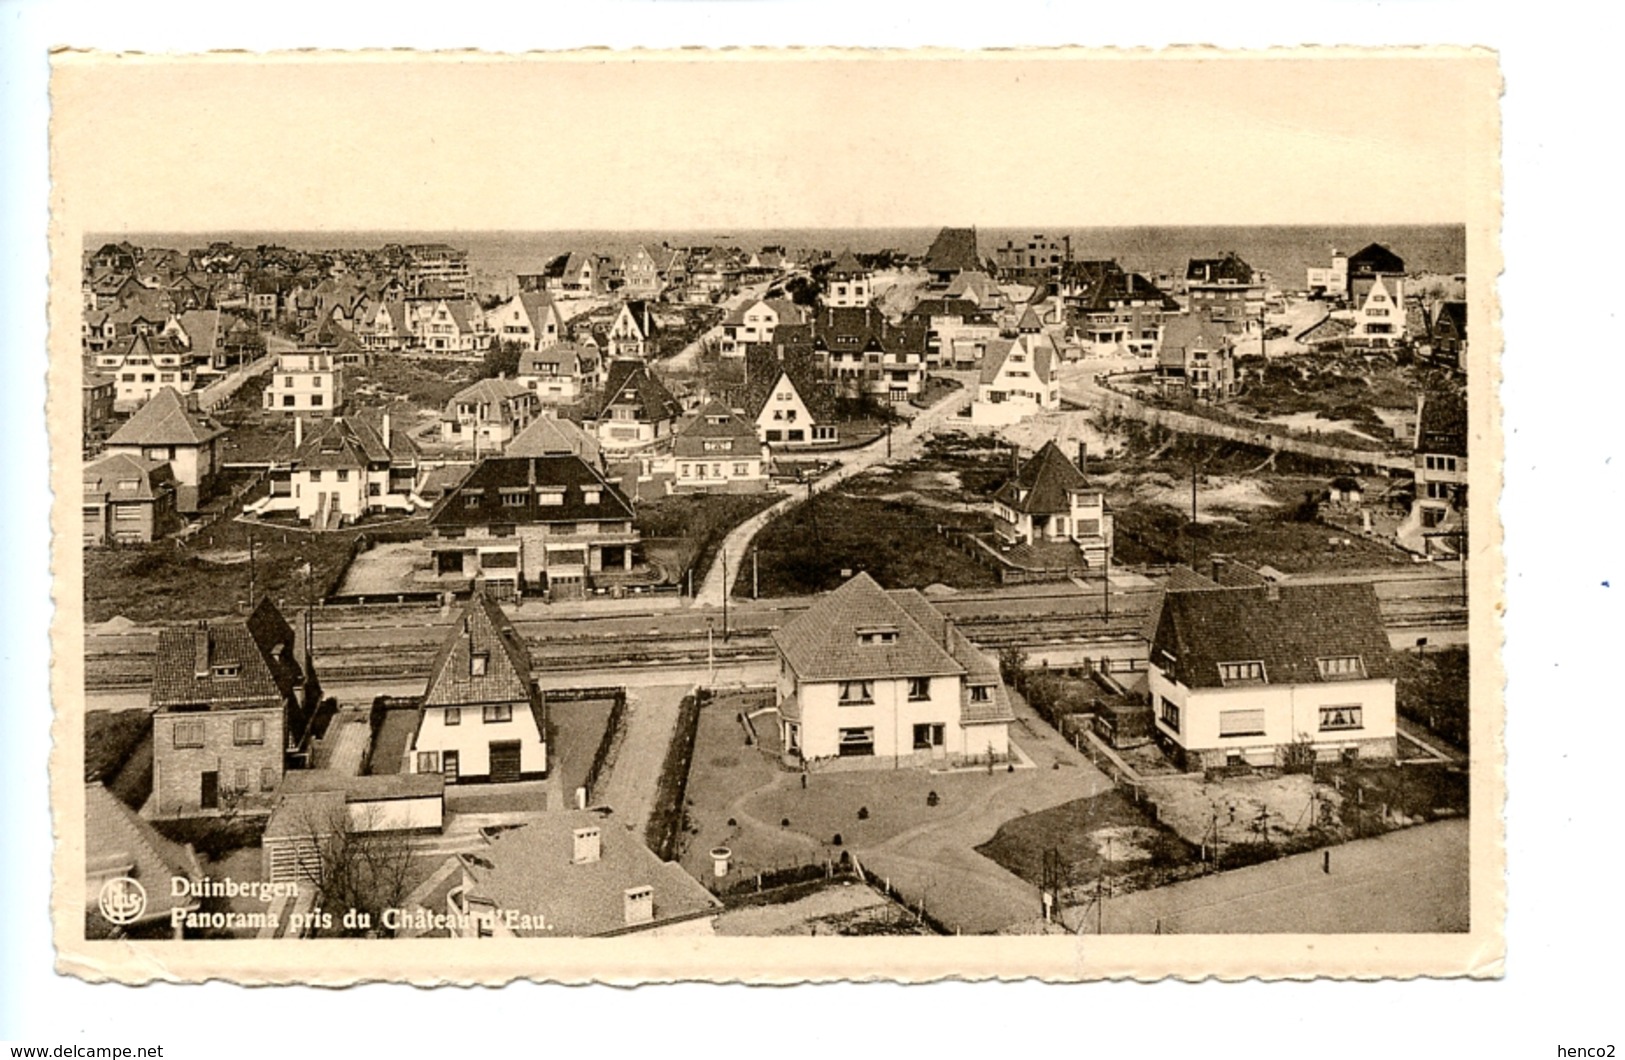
[774,572,965,681]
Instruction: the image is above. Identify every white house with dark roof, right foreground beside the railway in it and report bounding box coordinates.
[1149,584,1396,771]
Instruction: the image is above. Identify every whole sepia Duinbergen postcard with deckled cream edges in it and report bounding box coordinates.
[50,49,1505,984]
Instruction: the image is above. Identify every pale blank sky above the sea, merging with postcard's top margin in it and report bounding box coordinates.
[52,50,1497,231]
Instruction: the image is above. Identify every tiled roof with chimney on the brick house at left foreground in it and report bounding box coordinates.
[153,597,304,710]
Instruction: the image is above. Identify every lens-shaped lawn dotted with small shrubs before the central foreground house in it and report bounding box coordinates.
[744,767,1009,850]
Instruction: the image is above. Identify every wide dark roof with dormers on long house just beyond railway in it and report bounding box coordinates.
[429,454,632,527]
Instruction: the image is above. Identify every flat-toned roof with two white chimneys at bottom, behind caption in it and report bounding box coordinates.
[413,810,722,938]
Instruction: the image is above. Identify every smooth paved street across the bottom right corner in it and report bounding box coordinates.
[1064,819,1469,935]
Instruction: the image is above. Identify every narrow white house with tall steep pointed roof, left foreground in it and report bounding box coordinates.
[400,589,548,787]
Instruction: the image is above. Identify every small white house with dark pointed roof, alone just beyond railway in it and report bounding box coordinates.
[993,441,1115,567]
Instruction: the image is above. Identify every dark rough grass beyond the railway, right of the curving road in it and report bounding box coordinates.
[735,491,996,597]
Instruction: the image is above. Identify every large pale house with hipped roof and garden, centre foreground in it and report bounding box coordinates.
[774,574,1014,769]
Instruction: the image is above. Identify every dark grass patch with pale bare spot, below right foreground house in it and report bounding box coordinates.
[977,792,1194,886]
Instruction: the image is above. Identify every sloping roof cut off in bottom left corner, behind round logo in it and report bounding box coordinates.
[85,784,203,933]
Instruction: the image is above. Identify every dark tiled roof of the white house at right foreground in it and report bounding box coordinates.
[1151,582,1394,688]
